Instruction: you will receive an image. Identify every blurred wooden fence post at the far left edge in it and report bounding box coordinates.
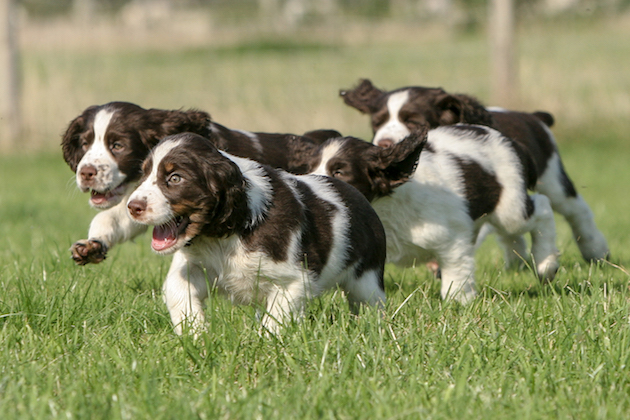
[0,0,21,150]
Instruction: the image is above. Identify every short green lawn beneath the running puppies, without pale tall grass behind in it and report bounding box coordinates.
[0,133,630,419]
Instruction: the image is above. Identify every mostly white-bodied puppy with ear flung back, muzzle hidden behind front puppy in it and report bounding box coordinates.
[311,125,558,303]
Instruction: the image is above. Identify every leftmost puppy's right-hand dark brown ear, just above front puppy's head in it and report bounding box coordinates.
[140,109,211,148]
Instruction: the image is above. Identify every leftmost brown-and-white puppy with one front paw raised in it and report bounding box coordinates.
[61,102,340,265]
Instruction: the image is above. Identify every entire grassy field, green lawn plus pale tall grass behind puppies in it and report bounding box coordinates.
[0,14,630,419]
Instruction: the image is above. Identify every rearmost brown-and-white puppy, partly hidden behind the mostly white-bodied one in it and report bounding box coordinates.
[340,79,610,261]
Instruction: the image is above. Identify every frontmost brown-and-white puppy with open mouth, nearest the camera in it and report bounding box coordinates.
[126,133,385,334]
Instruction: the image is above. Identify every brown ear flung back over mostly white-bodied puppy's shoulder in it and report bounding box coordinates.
[372,126,429,193]
